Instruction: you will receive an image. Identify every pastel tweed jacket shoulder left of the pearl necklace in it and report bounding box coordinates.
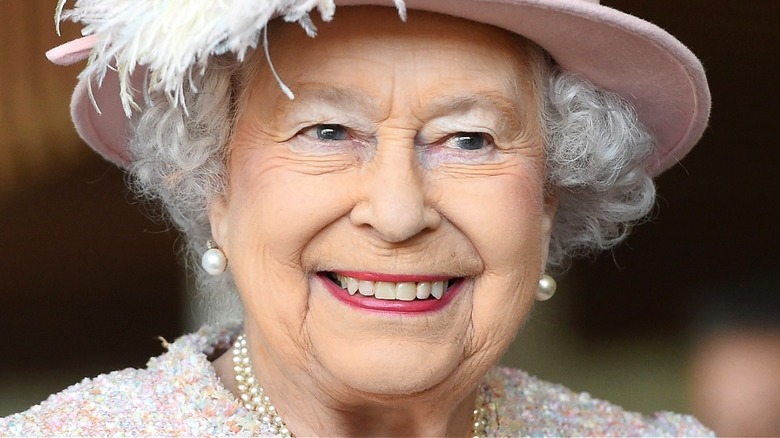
[0,330,255,436]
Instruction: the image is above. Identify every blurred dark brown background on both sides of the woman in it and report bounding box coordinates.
[0,0,780,435]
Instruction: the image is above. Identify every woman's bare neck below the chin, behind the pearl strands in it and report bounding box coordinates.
[214,332,477,436]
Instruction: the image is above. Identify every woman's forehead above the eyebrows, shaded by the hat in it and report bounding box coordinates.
[245,7,535,121]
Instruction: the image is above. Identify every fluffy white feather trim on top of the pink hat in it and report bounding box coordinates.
[55,0,406,117]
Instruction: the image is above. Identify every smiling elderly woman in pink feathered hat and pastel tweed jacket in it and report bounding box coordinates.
[0,0,709,436]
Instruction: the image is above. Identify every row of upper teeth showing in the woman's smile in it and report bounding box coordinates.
[336,275,454,301]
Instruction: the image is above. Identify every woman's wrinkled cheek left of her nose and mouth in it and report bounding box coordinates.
[226,153,362,355]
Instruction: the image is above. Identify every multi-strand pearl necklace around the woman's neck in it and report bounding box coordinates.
[233,334,488,438]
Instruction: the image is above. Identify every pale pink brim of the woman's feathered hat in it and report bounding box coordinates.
[50,0,710,176]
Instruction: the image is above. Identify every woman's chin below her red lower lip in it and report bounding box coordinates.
[308,282,472,396]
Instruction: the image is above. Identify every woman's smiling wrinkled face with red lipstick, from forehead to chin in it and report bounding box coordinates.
[210,8,554,404]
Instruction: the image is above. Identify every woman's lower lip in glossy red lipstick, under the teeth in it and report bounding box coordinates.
[316,274,466,313]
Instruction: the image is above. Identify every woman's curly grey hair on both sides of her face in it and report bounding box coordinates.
[128,37,655,321]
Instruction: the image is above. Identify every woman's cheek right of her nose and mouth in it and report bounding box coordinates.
[436,168,543,356]
